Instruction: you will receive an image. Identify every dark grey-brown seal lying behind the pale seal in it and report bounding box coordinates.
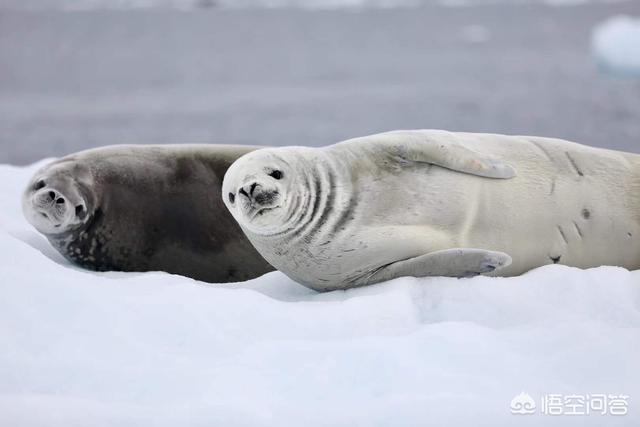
[23,145,273,282]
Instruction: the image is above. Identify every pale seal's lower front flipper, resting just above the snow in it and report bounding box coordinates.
[358,248,511,285]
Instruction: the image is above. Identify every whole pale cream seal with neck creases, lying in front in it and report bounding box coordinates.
[222,130,640,290]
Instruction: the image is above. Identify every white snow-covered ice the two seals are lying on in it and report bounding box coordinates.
[0,160,640,427]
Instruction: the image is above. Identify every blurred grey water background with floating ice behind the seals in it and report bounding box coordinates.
[0,0,640,164]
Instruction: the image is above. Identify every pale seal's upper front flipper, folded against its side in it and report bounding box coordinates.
[382,130,516,179]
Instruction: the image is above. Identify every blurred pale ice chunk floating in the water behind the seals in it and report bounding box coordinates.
[592,15,640,77]
